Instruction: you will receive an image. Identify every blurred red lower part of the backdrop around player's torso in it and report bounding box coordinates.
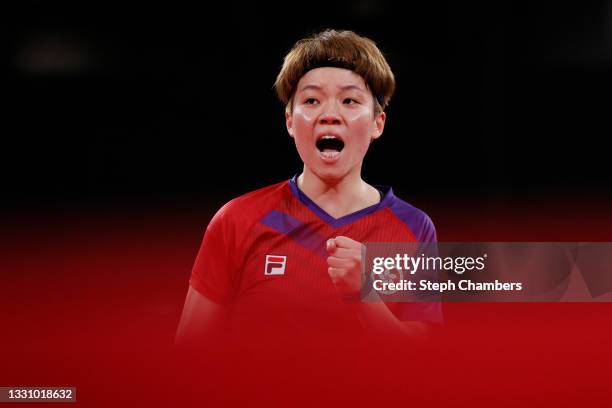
[0,196,612,406]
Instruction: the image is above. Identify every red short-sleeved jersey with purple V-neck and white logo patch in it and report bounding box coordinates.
[190,177,442,342]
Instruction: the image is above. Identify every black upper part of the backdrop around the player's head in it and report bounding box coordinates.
[0,0,612,214]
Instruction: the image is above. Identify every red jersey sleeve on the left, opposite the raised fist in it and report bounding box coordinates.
[189,205,241,305]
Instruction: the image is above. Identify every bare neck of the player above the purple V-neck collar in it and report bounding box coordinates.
[297,167,380,218]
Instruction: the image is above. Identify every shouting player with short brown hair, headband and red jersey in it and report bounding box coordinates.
[177,30,442,350]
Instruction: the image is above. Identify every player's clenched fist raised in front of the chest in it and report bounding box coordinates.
[327,236,363,299]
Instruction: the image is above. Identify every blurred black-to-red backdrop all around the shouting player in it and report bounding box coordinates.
[0,0,612,406]
